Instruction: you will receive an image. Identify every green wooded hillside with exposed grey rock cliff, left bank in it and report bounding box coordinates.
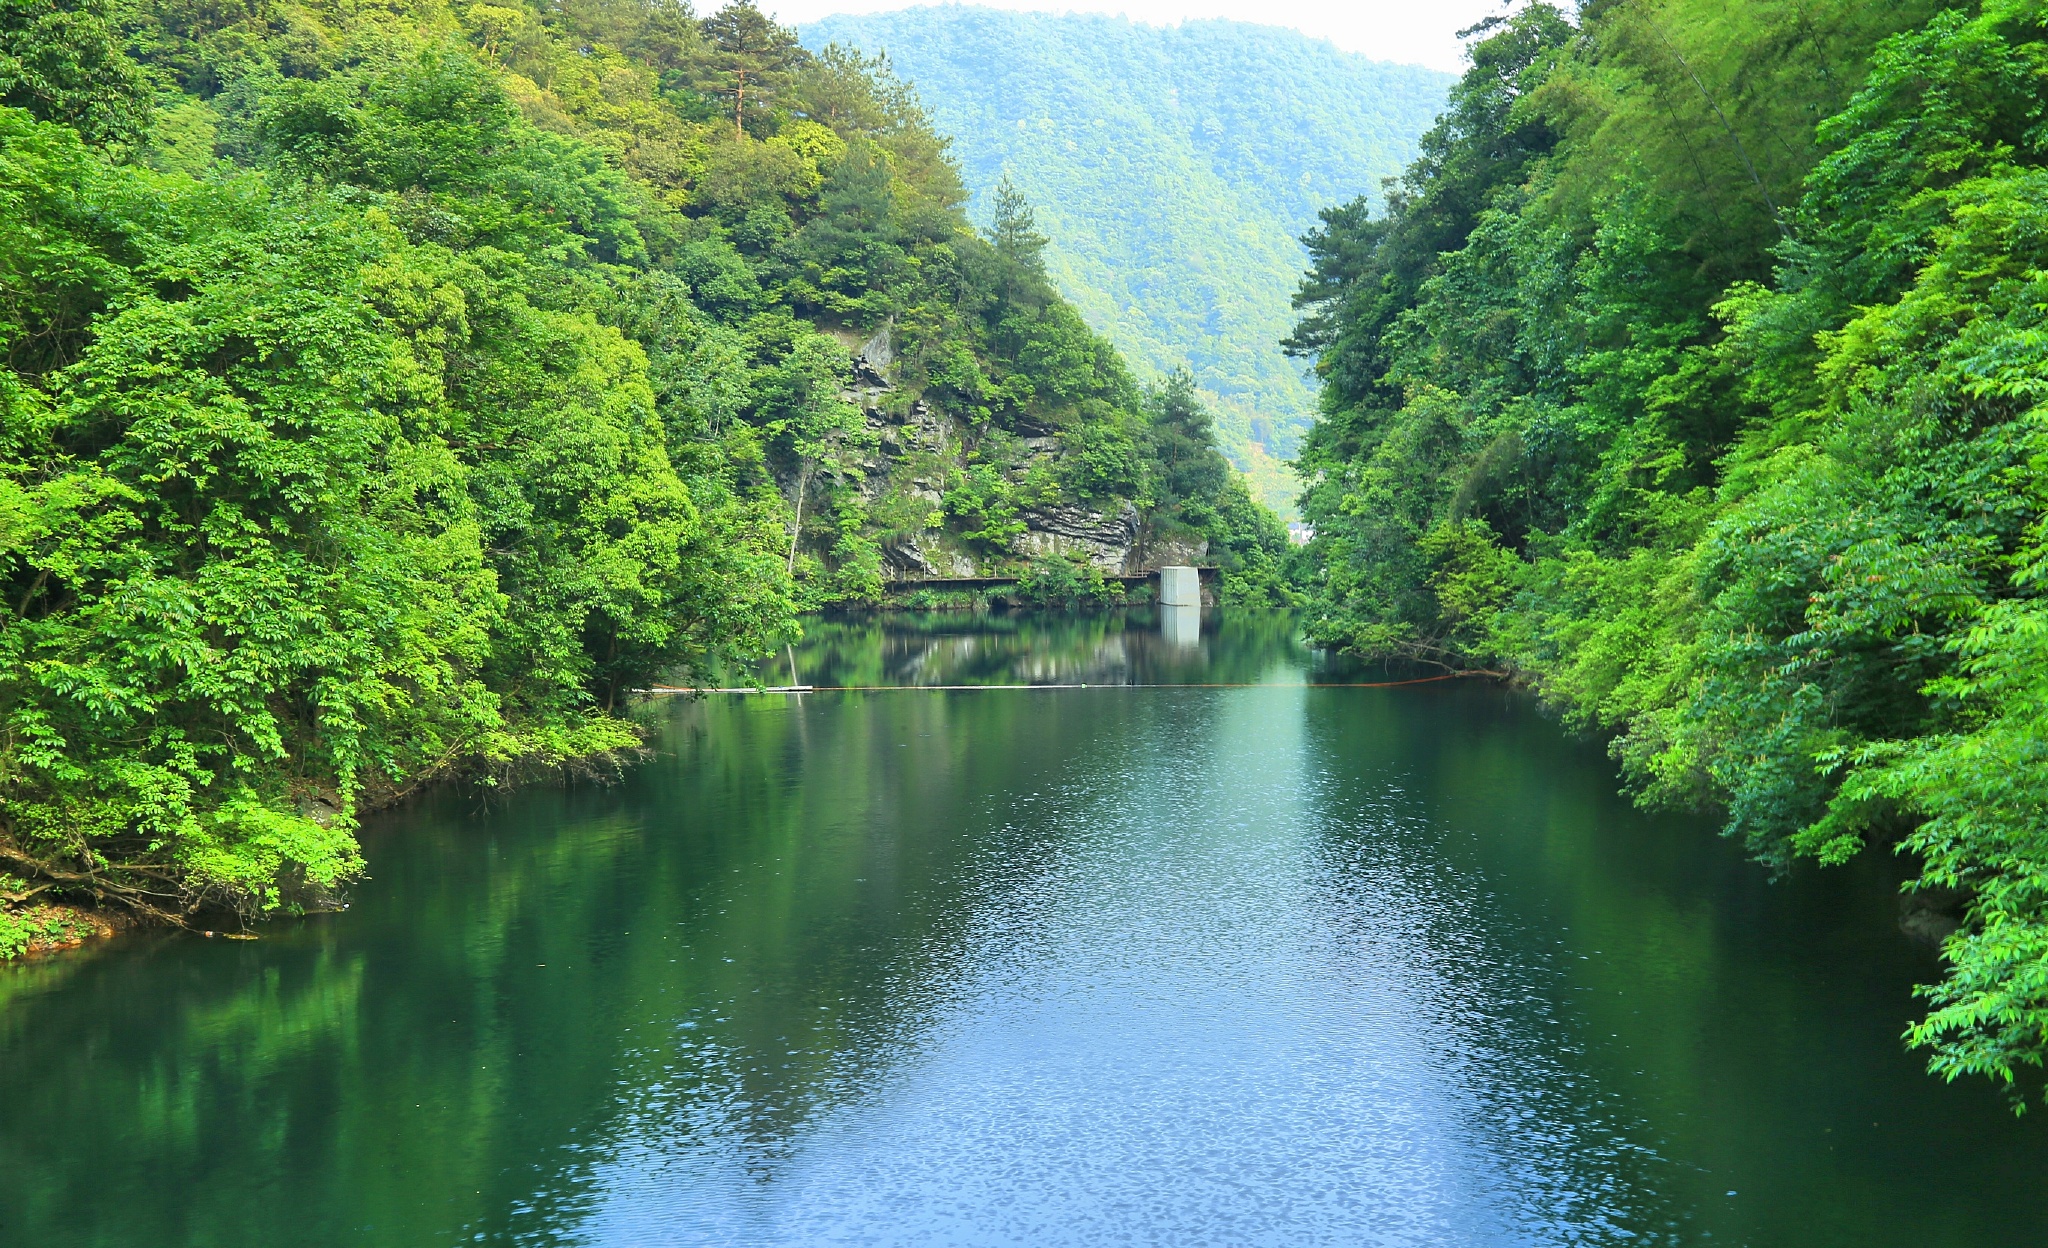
[0,0,1284,942]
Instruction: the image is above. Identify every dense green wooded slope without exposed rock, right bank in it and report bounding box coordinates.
[1292,0,2048,1082]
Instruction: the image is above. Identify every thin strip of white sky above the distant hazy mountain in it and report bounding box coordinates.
[760,0,1511,72]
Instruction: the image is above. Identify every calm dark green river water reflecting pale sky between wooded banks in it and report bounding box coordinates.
[0,613,2048,1248]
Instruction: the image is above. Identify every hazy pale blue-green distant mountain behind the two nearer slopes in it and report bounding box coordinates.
[803,6,1450,506]
